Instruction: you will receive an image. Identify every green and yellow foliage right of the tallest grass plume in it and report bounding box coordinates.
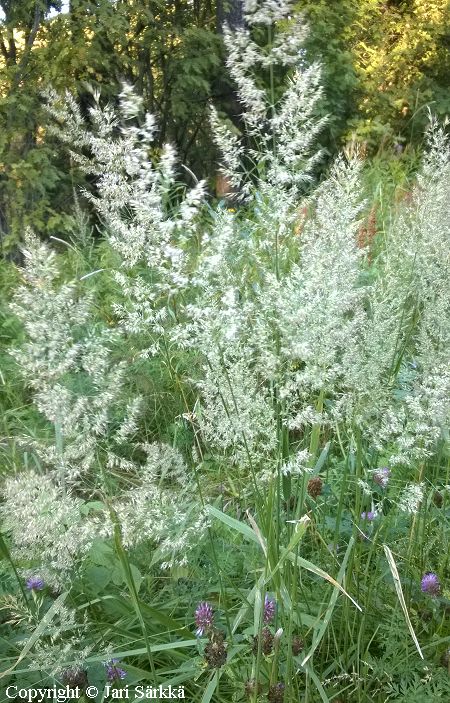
[296,0,450,151]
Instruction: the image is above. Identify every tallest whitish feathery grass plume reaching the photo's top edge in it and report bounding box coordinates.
[211,1,327,200]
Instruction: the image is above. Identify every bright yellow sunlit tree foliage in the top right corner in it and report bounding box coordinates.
[349,0,450,147]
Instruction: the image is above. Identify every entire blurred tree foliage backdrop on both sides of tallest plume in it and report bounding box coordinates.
[0,0,450,256]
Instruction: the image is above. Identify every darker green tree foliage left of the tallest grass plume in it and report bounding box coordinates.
[0,0,221,254]
